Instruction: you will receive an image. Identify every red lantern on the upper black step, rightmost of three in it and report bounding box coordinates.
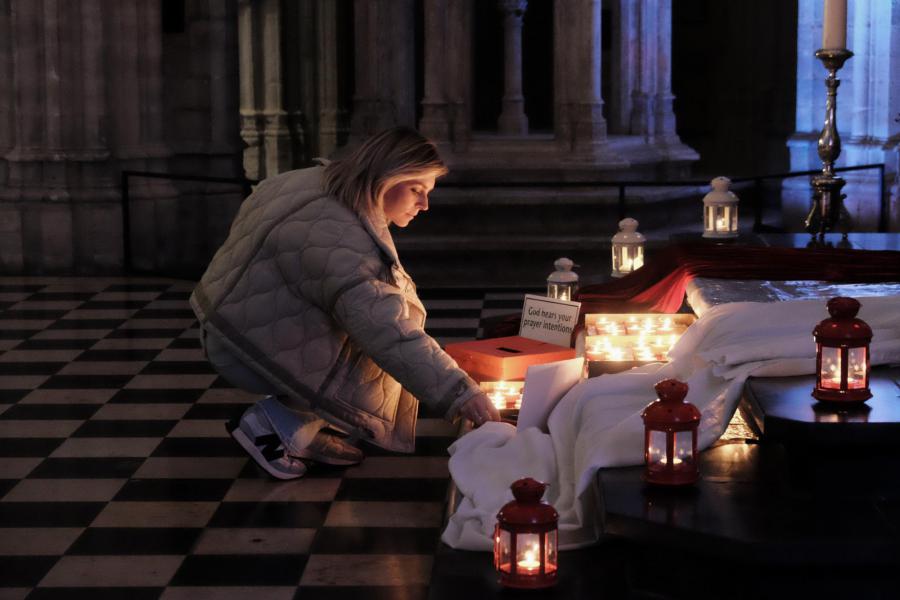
[812,298,872,402]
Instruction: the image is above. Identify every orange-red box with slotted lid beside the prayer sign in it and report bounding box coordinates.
[445,335,575,382]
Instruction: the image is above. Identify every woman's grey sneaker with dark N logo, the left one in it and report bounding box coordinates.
[226,404,306,479]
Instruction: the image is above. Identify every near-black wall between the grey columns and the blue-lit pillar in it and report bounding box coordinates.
[672,0,797,176]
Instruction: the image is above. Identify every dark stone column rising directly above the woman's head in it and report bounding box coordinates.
[350,0,416,139]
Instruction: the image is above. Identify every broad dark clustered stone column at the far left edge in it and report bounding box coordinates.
[0,0,174,272]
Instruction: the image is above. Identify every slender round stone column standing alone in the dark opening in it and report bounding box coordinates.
[497,0,528,135]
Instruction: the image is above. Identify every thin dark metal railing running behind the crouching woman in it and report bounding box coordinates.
[121,163,889,272]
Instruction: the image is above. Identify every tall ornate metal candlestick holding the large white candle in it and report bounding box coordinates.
[805,48,853,240]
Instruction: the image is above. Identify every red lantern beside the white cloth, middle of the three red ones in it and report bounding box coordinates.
[641,379,700,485]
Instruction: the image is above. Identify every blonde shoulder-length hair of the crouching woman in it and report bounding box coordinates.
[325,127,447,216]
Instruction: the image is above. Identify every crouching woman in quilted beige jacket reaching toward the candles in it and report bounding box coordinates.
[191,128,499,479]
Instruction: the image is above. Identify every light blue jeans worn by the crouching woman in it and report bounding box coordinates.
[201,330,327,455]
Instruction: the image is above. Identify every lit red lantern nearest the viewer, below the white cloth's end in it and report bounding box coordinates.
[494,477,559,589]
